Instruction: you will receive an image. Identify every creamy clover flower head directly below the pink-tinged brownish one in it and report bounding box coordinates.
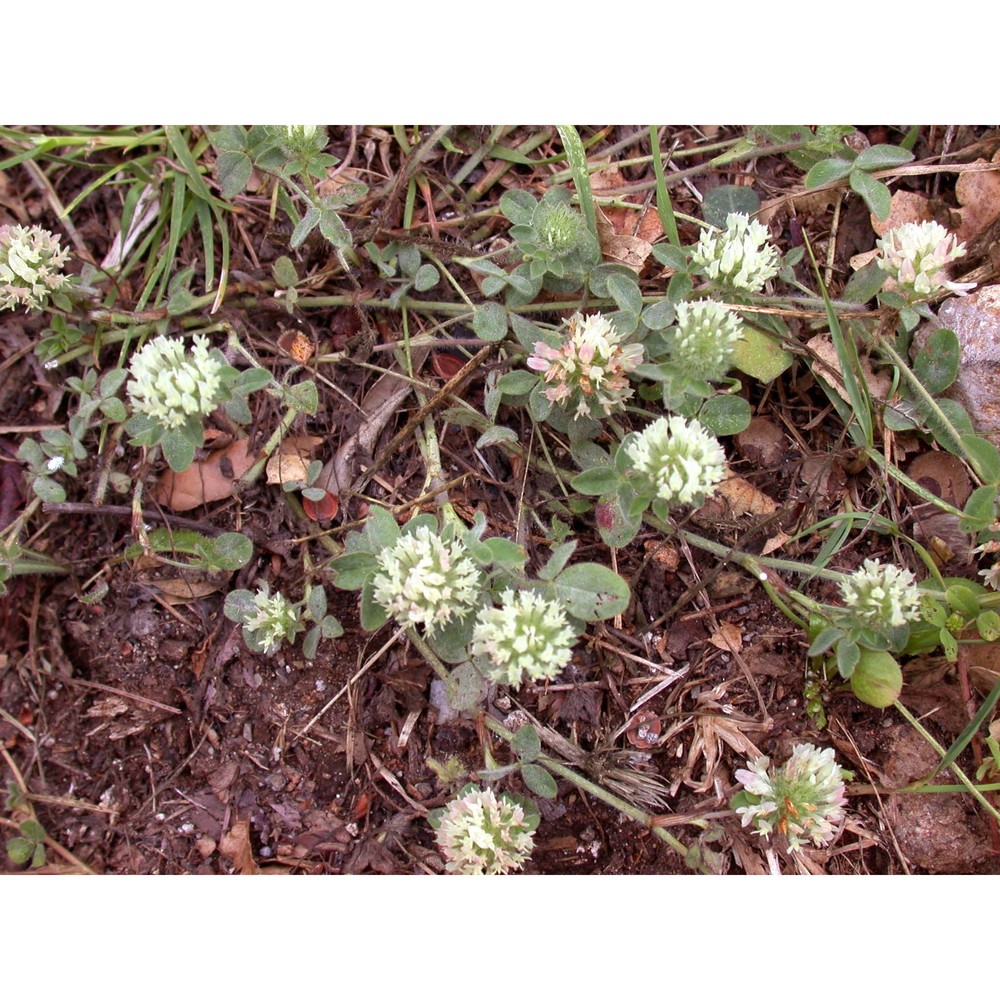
[625,417,726,507]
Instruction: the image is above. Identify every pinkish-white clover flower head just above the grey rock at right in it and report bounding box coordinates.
[875,222,976,302]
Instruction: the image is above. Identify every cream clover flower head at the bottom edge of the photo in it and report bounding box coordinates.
[436,787,534,875]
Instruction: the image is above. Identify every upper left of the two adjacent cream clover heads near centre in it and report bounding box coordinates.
[373,524,481,635]
